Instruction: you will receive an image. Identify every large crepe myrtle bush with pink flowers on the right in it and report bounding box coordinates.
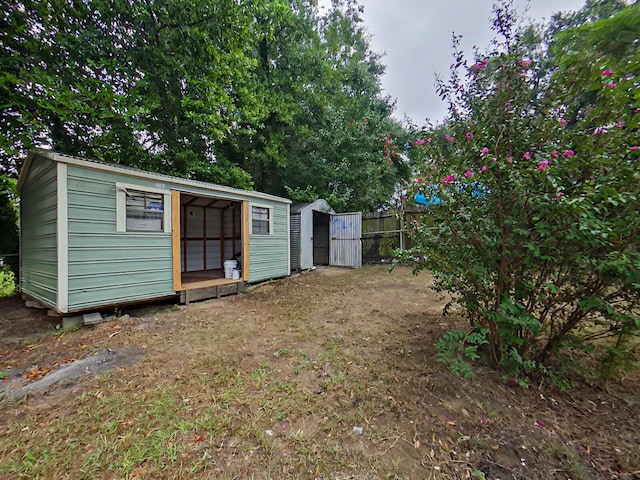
[399,1,640,383]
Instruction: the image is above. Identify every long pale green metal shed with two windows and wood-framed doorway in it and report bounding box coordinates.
[18,150,291,314]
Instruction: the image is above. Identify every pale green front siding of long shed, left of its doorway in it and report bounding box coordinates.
[68,166,175,311]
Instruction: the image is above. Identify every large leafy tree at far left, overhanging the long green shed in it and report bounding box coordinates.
[0,0,260,186]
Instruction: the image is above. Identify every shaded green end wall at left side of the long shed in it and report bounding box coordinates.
[20,159,58,307]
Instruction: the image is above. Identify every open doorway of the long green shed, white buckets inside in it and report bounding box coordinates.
[174,192,246,289]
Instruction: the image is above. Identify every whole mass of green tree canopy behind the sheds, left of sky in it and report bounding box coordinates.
[0,0,406,209]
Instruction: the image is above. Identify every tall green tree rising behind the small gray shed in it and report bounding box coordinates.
[219,1,407,210]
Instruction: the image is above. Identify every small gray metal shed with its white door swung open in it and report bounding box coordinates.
[290,199,362,271]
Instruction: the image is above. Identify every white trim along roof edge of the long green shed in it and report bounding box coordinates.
[18,150,292,204]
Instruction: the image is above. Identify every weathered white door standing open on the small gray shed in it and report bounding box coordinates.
[329,212,362,268]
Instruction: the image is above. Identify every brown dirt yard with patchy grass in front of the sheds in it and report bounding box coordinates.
[0,267,640,480]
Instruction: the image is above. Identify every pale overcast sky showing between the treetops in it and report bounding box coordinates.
[322,0,585,126]
